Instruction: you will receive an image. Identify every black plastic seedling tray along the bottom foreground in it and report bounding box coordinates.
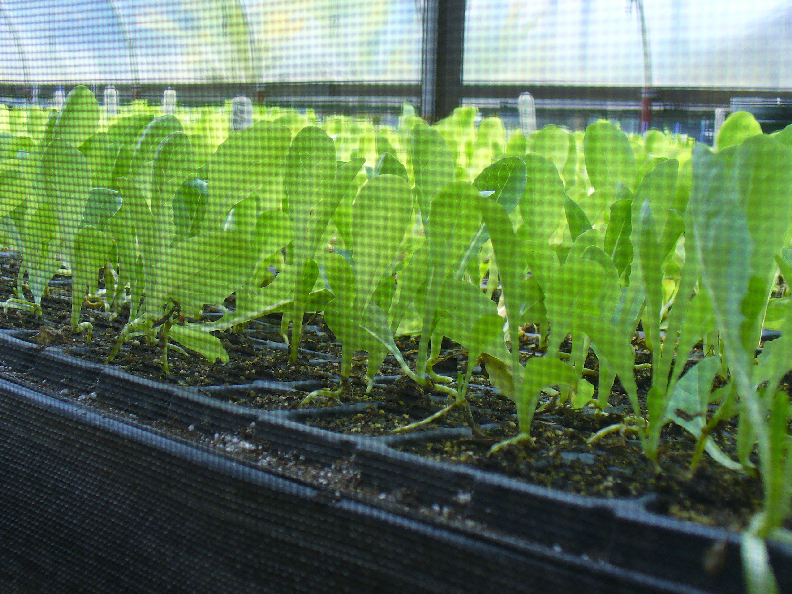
[0,332,792,594]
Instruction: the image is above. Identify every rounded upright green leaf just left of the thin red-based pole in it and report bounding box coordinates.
[583,120,636,190]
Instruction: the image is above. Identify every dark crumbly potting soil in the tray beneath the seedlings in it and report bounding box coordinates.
[0,256,780,529]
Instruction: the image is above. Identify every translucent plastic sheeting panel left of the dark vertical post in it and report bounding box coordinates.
[0,0,422,83]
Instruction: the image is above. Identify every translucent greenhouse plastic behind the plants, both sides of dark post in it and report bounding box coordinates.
[0,0,792,89]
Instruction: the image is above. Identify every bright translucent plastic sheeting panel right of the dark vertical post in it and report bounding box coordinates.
[464,0,792,89]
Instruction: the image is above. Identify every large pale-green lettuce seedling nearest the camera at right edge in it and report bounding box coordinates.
[688,135,792,536]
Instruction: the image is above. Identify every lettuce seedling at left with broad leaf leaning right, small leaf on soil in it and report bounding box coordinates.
[108,123,249,373]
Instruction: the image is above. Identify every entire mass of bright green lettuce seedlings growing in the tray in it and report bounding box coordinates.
[0,87,792,584]
